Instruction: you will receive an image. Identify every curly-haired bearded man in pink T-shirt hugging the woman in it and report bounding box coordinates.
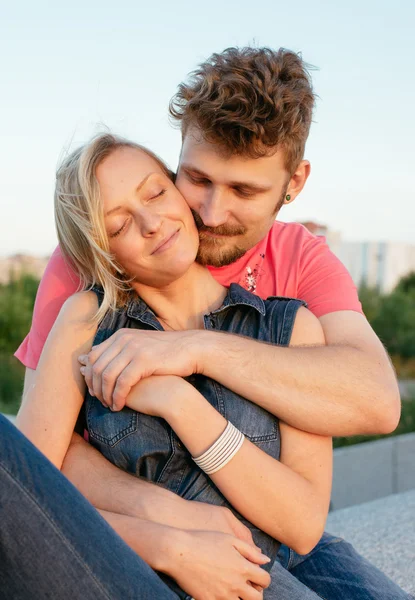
[17,48,405,599]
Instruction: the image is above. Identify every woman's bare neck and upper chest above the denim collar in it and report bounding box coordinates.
[133,263,227,330]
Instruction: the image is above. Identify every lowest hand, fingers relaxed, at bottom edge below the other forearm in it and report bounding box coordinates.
[163,531,271,600]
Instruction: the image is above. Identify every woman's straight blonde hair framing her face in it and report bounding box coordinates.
[55,133,173,322]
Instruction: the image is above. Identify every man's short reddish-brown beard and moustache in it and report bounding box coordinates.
[192,187,287,267]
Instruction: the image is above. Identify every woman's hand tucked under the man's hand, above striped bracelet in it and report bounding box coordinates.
[126,375,195,419]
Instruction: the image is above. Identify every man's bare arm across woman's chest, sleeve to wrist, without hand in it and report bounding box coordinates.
[200,311,400,436]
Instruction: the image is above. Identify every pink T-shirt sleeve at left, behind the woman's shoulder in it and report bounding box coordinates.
[15,247,80,369]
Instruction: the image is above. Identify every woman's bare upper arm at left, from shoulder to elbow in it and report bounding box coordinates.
[16,292,98,469]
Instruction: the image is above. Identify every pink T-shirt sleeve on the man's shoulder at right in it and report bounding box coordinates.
[298,236,363,317]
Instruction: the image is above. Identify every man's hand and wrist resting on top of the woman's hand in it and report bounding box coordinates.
[79,329,204,410]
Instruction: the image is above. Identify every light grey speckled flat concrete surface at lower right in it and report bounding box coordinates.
[326,490,415,593]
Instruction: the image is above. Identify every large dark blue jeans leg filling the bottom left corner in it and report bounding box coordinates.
[0,415,177,600]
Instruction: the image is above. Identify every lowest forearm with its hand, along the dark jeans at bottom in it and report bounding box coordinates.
[100,511,270,600]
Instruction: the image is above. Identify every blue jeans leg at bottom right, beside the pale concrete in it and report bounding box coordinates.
[264,533,412,600]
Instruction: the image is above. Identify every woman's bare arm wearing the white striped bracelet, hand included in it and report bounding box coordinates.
[127,309,332,554]
